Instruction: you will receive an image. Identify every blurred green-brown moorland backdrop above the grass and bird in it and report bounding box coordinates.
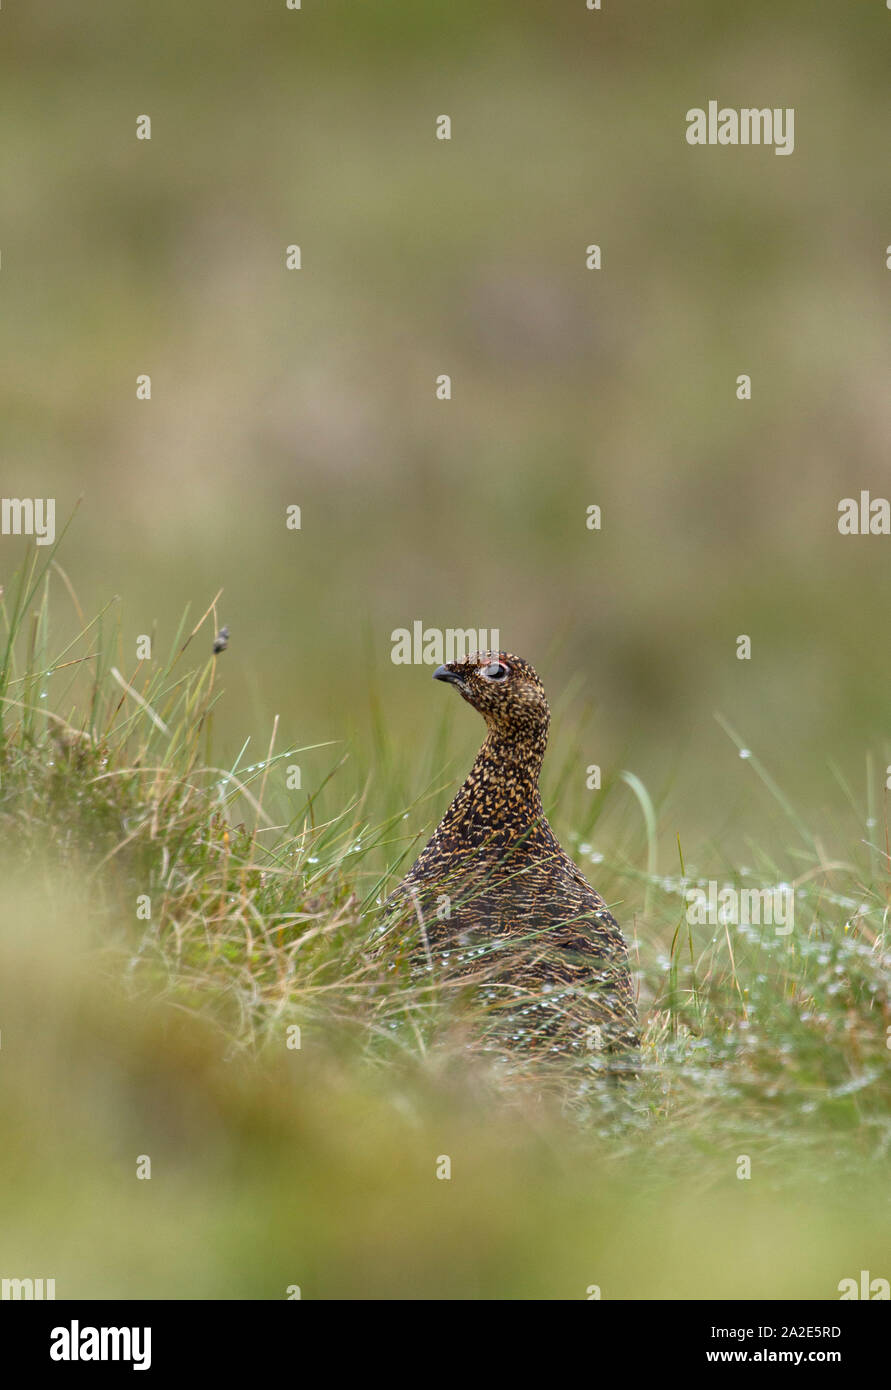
[0,0,891,834]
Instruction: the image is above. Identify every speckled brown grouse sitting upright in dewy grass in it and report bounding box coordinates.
[386,652,638,1056]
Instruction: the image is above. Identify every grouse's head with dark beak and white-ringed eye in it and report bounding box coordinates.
[434,652,550,742]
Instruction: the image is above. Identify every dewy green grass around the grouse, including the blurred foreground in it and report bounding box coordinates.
[0,556,891,1298]
